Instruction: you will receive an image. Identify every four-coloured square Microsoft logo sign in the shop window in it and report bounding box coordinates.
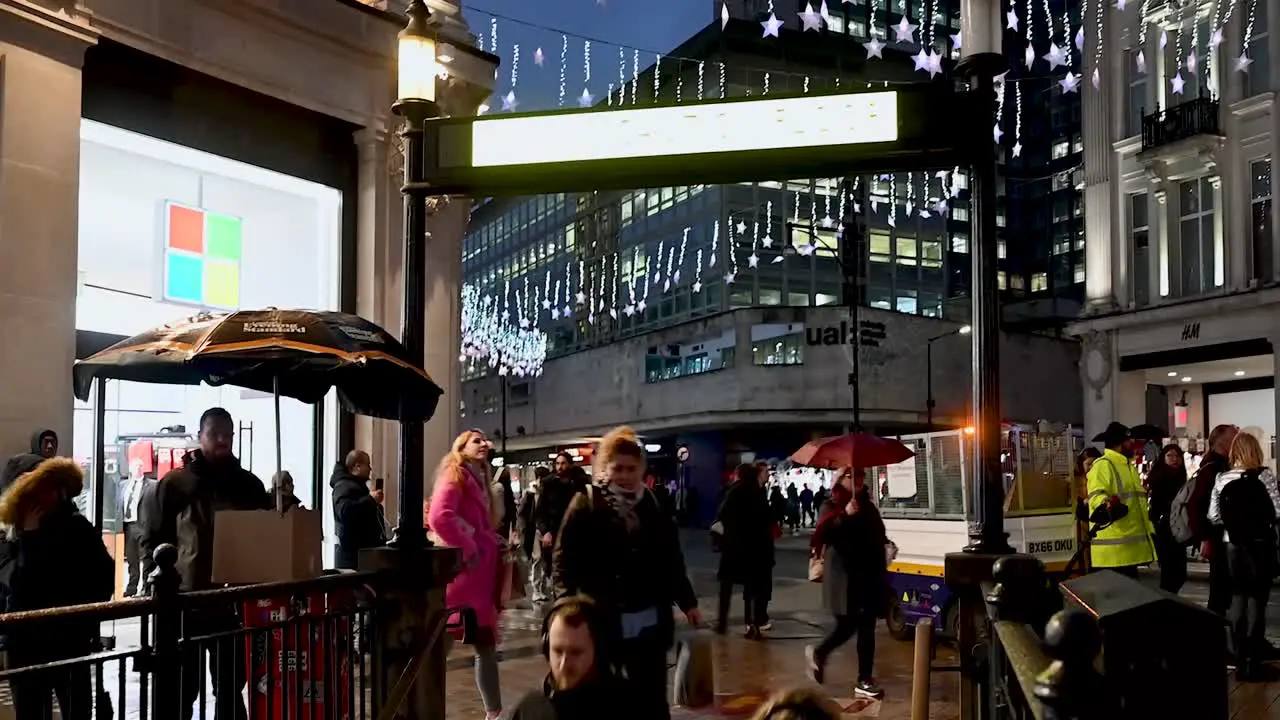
[164,201,242,310]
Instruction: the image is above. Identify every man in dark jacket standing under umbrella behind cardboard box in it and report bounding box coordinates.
[138,407,275,720]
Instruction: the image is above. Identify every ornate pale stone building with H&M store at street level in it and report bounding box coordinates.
[1073,0,1280,448]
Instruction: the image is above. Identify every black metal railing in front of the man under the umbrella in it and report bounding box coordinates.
[0,547,404,720]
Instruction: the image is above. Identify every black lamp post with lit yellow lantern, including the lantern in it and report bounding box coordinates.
[392,0,440,548]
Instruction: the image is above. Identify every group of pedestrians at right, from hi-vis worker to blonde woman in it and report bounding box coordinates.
[1079,423,1280,682]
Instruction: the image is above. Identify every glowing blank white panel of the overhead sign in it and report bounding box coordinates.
[471,91,899,168]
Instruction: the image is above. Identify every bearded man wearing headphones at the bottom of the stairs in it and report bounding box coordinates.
[511,596,640,720]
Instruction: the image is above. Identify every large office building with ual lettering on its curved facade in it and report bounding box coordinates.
[461,8,1079,517]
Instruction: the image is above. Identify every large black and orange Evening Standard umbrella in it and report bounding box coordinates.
[73,309,443,421]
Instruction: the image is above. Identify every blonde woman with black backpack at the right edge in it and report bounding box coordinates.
[1208,432,1280,680]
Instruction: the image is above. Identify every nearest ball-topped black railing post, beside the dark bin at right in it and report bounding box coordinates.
[1036,610,1107,720]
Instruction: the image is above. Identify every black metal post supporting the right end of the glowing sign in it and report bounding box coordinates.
[957,53,1012,555]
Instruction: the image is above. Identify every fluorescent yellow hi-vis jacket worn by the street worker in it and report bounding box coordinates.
[1088,450,1156,568]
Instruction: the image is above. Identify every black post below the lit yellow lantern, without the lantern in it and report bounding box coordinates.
[392,100,439,548]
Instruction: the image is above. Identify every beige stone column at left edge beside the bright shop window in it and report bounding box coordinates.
[0,0,97,456]
